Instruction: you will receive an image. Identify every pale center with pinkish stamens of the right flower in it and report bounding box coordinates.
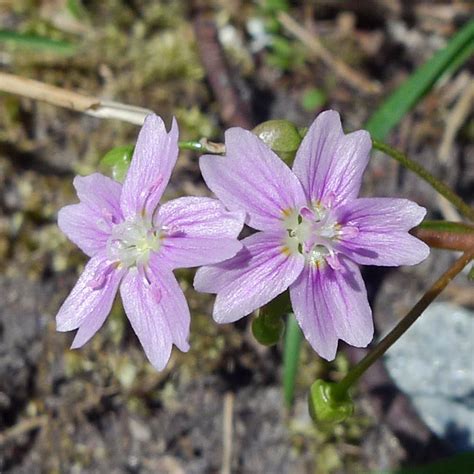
[283,203,358,270]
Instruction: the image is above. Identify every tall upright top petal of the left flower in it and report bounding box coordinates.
[120,114,179,217]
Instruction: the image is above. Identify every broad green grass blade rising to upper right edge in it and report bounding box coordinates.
[364,20,474,140]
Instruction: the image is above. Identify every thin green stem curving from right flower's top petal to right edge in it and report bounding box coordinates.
[372,139,474,221]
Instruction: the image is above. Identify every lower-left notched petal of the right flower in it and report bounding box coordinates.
[194,232,304,323]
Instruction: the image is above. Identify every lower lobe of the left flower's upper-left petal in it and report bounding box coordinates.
[58,203,110,257]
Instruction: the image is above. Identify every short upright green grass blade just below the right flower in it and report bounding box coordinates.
[283,313,302,408]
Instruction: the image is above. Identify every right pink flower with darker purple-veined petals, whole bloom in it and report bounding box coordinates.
[194,111,429,360]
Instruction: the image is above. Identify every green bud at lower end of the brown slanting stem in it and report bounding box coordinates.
[308,380,354,423]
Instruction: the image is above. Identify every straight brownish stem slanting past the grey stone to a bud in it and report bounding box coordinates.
[333,249,474,399]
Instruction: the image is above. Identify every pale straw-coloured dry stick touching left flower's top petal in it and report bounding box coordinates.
[0,72,153,125]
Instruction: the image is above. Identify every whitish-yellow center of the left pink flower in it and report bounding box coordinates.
[107,216,162,268]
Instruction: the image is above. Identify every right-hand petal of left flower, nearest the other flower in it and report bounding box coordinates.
[157,197,245,268]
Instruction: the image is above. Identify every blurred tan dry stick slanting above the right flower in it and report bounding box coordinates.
[278,13,382,94]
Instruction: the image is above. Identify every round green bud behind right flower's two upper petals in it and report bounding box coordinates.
[252,120,301,165]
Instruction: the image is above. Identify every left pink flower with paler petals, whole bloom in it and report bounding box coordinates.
[56,115,244,370]
